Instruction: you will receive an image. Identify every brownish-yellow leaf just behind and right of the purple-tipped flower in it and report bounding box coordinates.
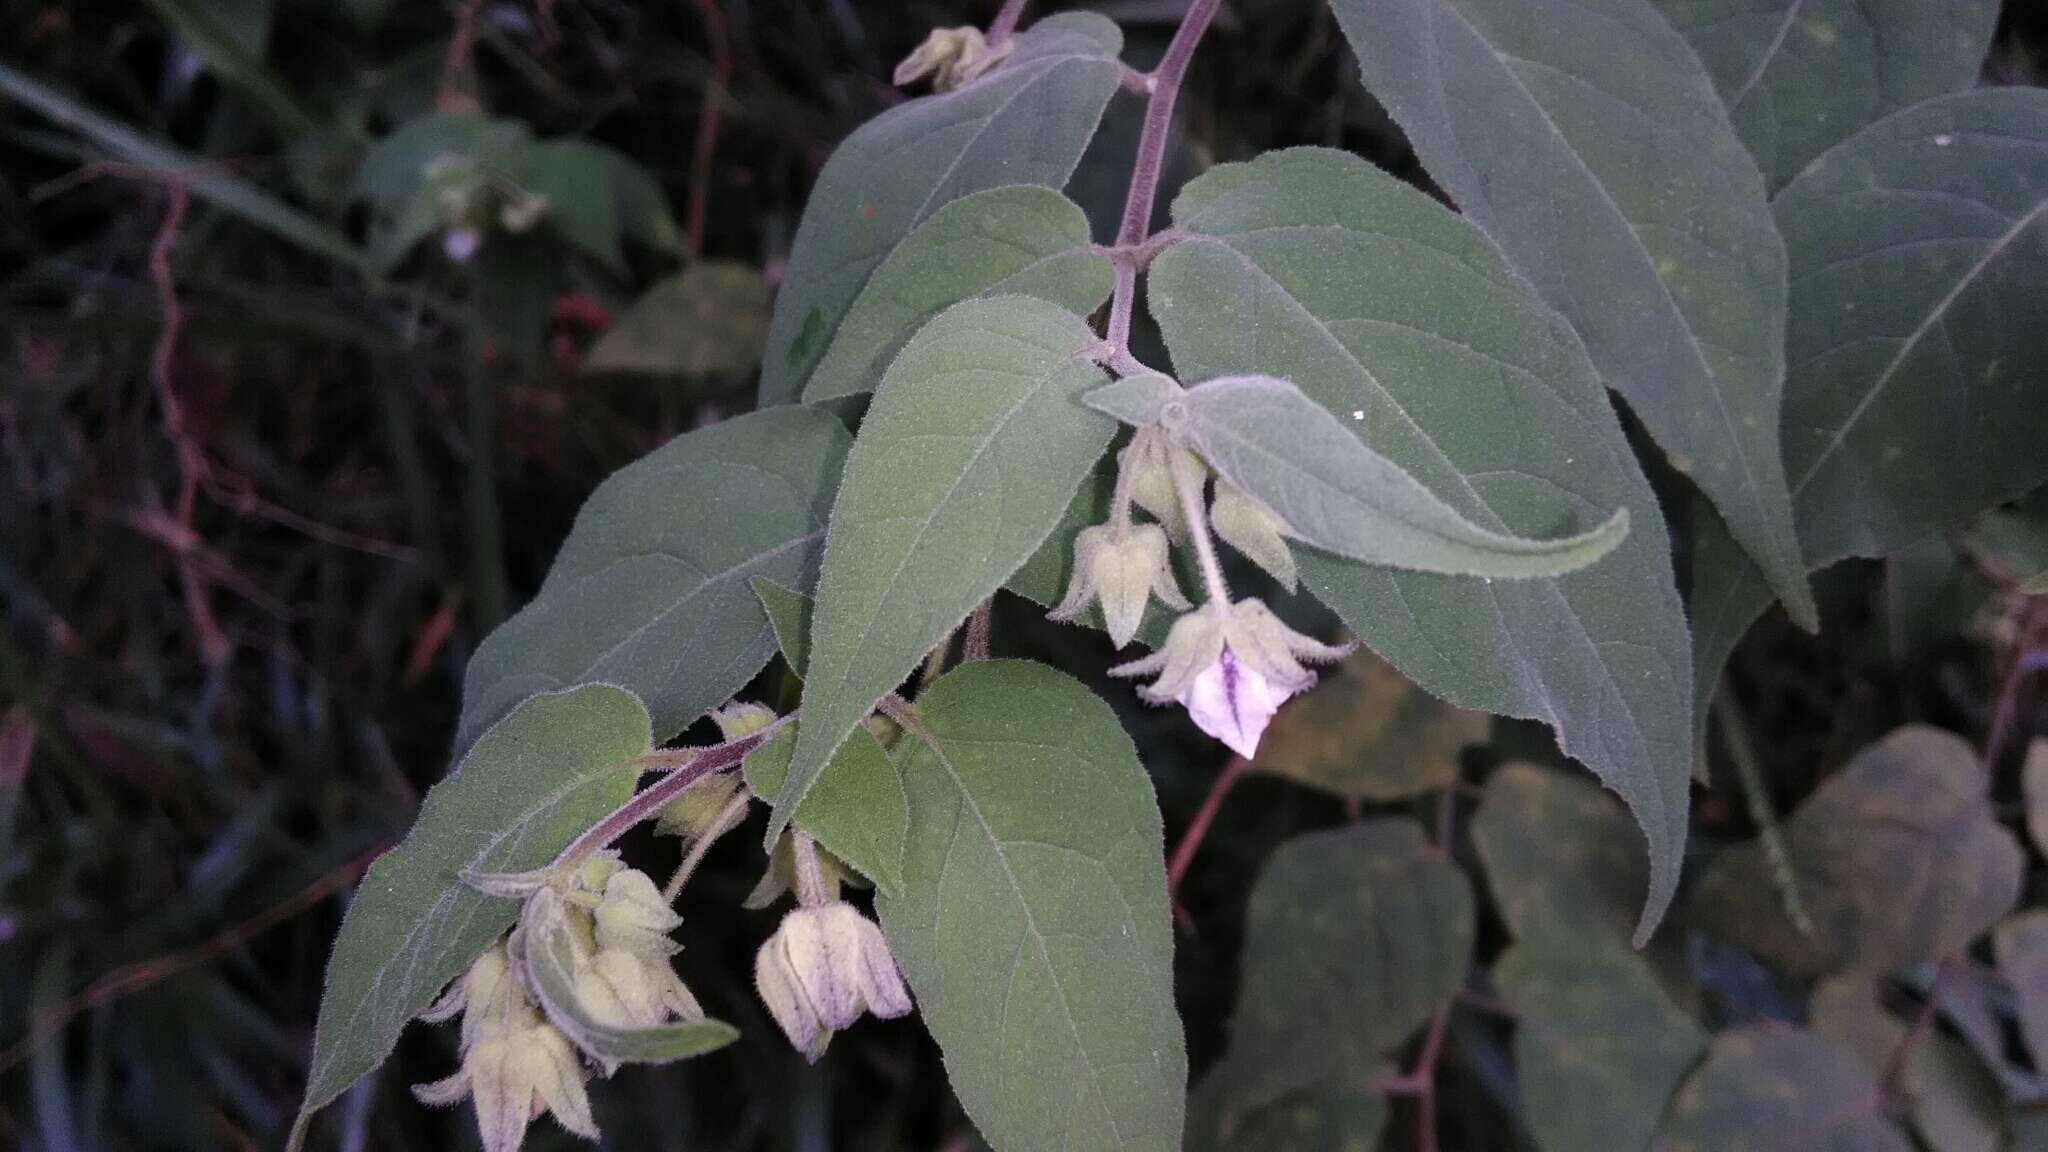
[1251,648,1493,804]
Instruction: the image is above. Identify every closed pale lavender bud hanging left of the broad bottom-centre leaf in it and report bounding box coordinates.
[754,900,911,1062]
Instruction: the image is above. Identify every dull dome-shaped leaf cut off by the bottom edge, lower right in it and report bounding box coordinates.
[1655,1023,1913,1152]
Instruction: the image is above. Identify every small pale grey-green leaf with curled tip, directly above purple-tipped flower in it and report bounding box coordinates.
[1169,375,1628,580]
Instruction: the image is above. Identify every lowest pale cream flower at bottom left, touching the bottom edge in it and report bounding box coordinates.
[412,941,598,1152]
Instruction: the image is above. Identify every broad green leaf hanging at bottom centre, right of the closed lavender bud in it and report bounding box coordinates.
[874,660,1188,1152]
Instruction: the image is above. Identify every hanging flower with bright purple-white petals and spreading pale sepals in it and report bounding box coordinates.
[1110,599,1354,760]
